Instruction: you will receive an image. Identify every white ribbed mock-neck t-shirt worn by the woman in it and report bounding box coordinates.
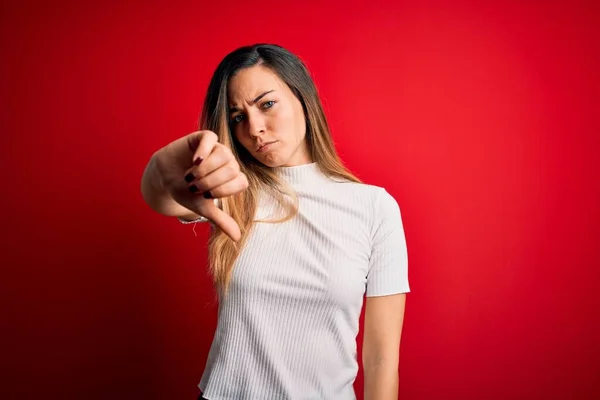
[180,163,410,400]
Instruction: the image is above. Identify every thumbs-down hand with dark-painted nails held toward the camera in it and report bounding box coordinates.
[155,131,248,241]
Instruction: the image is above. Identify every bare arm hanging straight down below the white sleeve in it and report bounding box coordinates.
[362,293,406,400]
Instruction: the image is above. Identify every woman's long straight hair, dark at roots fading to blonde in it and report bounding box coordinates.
[200,44,360,294]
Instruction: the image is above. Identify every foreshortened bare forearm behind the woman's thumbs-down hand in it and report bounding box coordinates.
[141,155,199,220]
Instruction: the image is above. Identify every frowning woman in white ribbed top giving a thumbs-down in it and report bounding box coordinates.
[142,44,409,400]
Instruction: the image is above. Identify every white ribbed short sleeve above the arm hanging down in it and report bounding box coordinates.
[366,189,410,297]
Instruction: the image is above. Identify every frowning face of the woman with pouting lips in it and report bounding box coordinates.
[227,65,312,167]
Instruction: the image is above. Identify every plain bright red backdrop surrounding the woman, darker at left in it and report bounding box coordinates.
[0,0,600,400]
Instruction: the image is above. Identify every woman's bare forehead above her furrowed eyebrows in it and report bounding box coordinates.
[227,65,287,102]
